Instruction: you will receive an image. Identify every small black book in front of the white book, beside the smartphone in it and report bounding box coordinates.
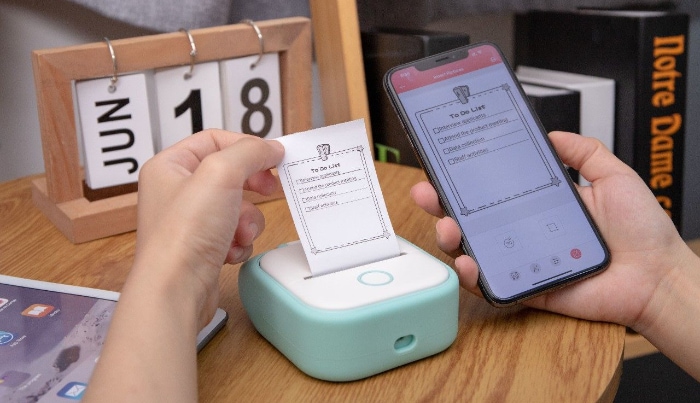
[521,83,585,184]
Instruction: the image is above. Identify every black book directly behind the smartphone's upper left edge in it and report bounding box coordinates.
[361,28,469,167]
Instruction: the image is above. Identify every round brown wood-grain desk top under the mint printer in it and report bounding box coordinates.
[0,164,625,402]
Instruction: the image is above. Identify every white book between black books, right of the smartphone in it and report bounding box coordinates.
[515,66,615,185]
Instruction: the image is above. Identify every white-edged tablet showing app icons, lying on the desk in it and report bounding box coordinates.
[0,275,227,403]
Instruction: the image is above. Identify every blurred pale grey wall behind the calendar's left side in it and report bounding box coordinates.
[0,0,150,182]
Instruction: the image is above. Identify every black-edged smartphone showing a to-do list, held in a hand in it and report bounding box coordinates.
[384,43,610,306]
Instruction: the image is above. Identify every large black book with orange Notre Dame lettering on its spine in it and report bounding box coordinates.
[515,10,689,231]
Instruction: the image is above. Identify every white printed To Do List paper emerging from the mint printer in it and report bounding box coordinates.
[276,120,400,276]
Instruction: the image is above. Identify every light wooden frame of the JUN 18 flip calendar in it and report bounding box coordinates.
[32,17,312,243]
